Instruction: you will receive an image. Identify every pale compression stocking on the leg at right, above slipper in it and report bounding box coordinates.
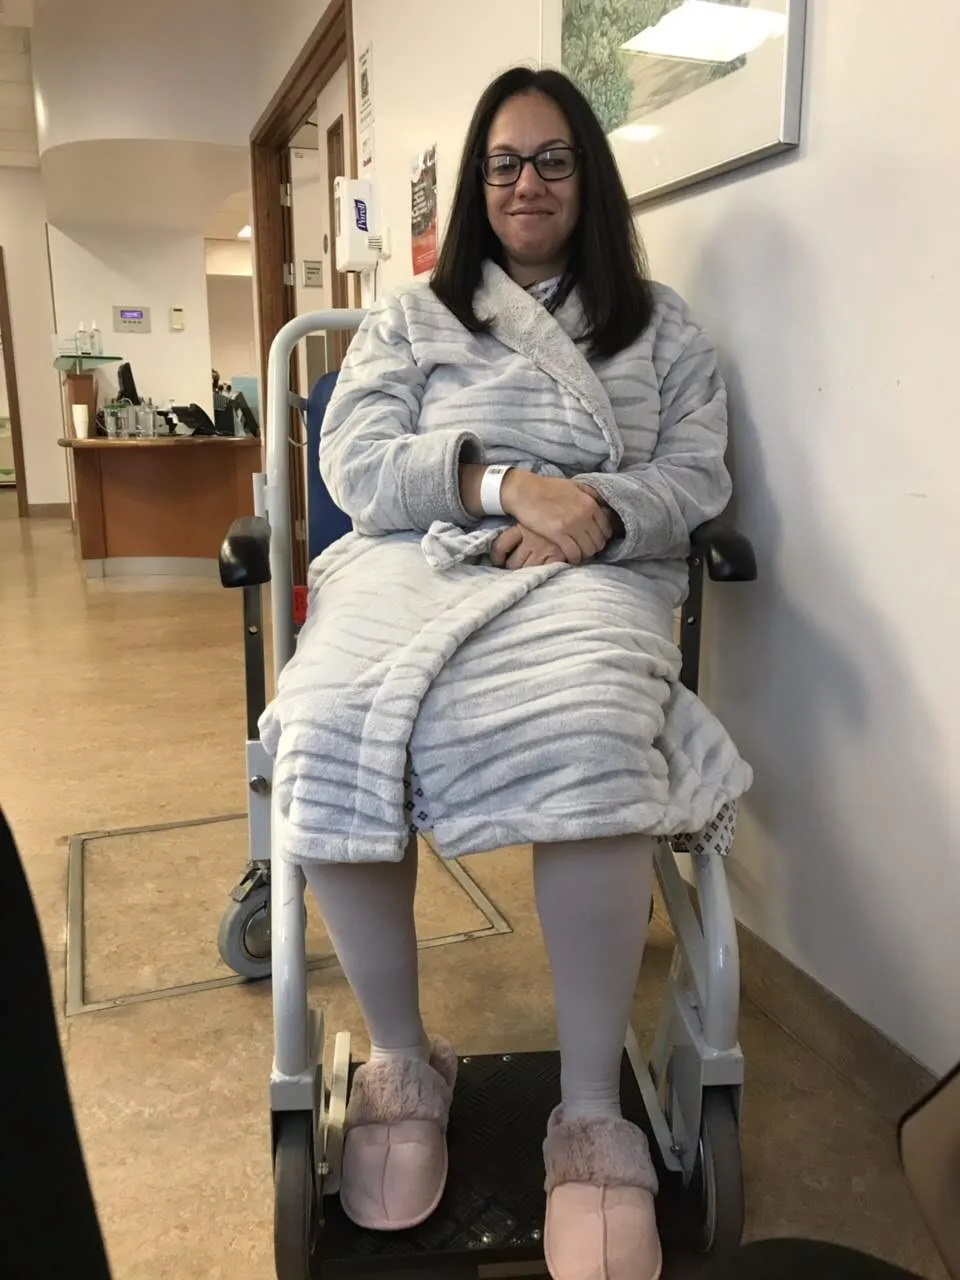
[534,836,655,1120]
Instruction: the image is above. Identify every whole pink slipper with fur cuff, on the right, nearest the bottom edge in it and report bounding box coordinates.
[544,1107,663,1280]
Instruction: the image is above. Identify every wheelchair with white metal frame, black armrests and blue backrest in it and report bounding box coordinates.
[219,310,756,1280]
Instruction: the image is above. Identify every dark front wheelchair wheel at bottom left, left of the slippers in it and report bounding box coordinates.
[274,1111,320,1280]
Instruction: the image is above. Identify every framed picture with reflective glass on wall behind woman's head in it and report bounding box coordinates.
[555,0,806,205]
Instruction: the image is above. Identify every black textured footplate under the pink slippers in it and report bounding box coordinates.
[316,1052,701,1276]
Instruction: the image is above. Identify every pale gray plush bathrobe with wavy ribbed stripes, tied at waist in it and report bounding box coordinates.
[261,262,751,861]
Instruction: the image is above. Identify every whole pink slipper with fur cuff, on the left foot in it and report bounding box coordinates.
[340,1038,457,1231]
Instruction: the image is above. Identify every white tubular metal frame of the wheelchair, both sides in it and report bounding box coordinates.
[256,310,744,1193]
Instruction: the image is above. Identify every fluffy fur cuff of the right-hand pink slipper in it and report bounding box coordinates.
[543,1107,658,1196]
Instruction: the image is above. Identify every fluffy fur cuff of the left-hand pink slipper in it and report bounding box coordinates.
[347,1038,457,1130]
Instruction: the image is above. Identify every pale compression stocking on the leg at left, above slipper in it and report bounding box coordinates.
[303,840,430,1061]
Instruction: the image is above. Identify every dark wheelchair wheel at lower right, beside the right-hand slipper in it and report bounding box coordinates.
[686,1088,744,1257]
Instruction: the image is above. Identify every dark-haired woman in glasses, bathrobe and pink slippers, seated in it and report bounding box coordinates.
[262,68,750,1280]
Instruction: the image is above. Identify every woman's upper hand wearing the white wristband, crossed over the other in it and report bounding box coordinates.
[500,467,613,564]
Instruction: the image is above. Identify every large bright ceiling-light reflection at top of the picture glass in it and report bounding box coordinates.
[623,0,787,63]
